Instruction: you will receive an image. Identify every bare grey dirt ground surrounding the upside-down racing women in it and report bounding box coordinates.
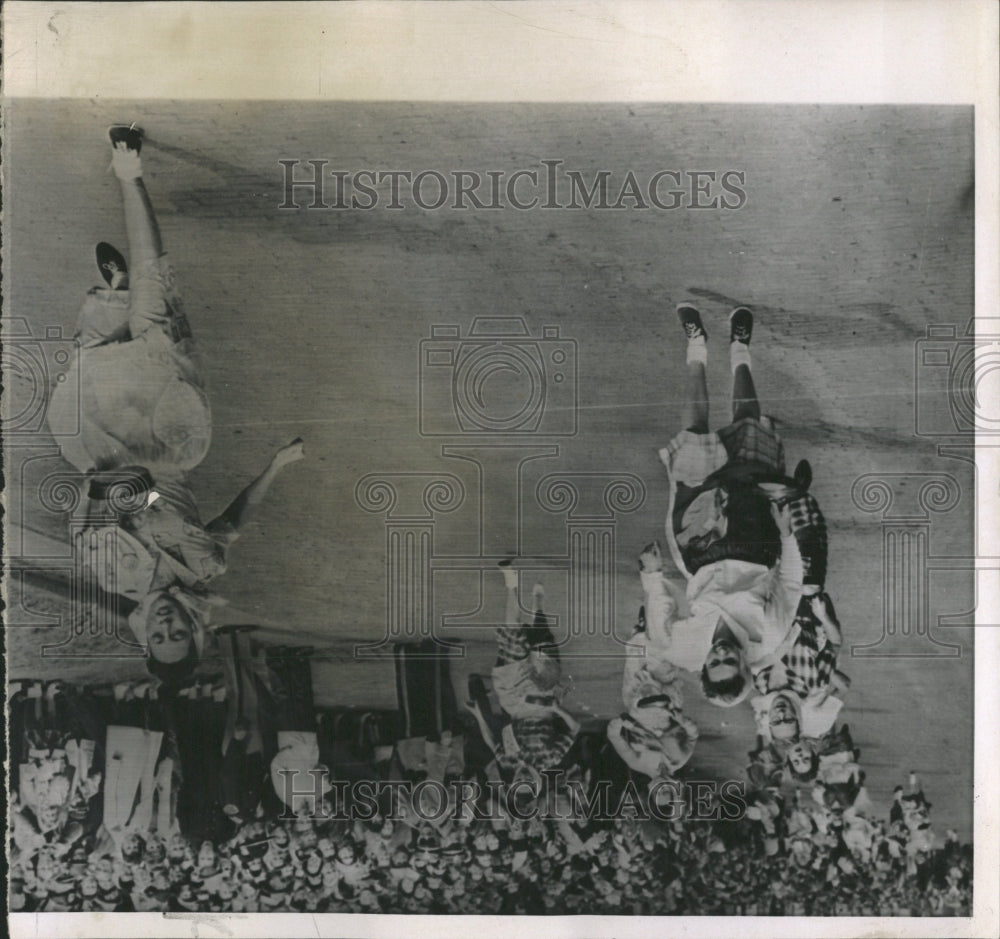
[4,100,974,837]
